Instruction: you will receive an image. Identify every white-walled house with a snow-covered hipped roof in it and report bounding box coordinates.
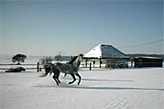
[84,44,129,68]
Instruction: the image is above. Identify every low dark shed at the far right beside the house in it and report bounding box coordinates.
[134,57,163,67]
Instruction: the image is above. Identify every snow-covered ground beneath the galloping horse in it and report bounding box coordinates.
[0,68,164,109]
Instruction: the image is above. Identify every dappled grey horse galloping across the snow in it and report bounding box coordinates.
[40,54,83,85]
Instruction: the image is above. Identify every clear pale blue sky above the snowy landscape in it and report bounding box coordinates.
[0,0,164,56]
